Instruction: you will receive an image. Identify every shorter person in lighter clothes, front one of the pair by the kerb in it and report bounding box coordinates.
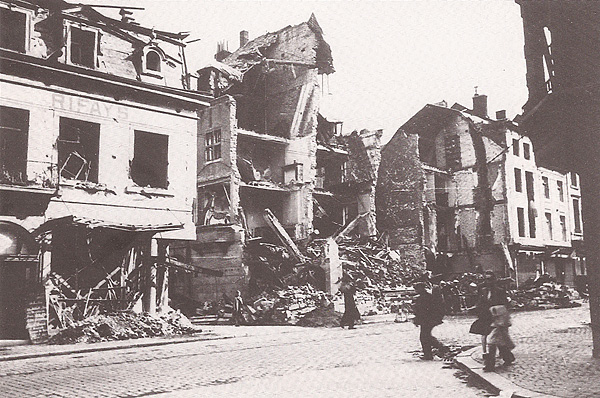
[483,305,515,372]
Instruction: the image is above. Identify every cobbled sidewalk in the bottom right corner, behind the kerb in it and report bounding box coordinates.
[456,305,600,398]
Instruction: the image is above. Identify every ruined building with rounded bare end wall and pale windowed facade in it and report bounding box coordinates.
[377,94,585,284]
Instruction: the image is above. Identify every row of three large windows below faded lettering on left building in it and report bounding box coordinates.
[0,106,169,189]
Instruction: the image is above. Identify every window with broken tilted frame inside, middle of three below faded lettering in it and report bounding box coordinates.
[58,117,100,182]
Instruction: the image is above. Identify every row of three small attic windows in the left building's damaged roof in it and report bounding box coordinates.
[0,7,163,73]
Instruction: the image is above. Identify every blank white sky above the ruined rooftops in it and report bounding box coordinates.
[83,0,527,140]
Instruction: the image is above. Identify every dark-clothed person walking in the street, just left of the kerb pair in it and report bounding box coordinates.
[413,282,444,361]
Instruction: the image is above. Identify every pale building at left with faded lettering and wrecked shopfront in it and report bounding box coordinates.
[0,0,211,341]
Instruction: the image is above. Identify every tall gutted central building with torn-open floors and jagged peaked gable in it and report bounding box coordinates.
[169,15,379,301]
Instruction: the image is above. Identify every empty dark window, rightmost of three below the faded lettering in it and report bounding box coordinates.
[131,130,169,189]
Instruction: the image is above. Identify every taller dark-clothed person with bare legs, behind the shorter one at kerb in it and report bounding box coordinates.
[469,271,508,359]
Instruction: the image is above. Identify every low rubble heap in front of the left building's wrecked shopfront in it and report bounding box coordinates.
[50,311,202,344]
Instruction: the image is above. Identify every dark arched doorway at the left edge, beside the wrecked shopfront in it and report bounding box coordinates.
[0,221,39,340]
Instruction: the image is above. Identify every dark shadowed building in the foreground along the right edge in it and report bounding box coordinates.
[516,0,600,357]
